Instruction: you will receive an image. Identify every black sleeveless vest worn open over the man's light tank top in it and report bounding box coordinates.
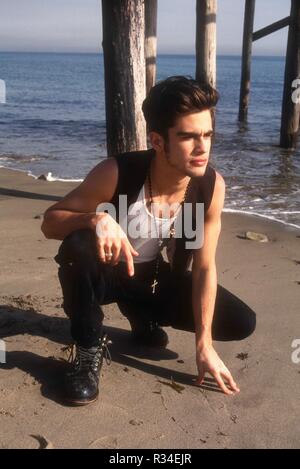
[110,149,216,272]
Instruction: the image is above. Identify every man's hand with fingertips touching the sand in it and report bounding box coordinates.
[196,345,240,395]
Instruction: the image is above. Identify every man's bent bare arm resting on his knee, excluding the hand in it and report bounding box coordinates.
[41,158,118,240]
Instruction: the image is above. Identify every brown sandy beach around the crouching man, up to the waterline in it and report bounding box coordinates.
[0,168,300,449]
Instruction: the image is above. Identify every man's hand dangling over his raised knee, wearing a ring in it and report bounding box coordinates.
[94,212,139,277]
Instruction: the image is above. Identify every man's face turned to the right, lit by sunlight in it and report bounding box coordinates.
[164,110,213,177]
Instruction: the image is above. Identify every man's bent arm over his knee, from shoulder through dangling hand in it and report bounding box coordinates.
[41,158,138,276]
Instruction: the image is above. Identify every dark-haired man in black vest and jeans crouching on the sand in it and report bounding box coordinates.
[42,77,255,405]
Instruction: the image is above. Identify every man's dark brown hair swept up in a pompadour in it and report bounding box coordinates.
[142,76,219,139]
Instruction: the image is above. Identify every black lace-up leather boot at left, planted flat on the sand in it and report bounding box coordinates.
[65,334,111,405]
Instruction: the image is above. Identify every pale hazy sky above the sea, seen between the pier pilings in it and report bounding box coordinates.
[0,0,290,55]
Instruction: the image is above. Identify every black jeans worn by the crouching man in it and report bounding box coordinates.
[55,230,256,347]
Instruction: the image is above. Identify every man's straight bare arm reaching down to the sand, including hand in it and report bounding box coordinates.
[192,173,239,394]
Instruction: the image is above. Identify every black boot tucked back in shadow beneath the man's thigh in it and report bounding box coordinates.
[129,319,169,347]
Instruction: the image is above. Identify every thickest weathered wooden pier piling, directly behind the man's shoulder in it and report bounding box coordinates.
[102,0,147,156]
